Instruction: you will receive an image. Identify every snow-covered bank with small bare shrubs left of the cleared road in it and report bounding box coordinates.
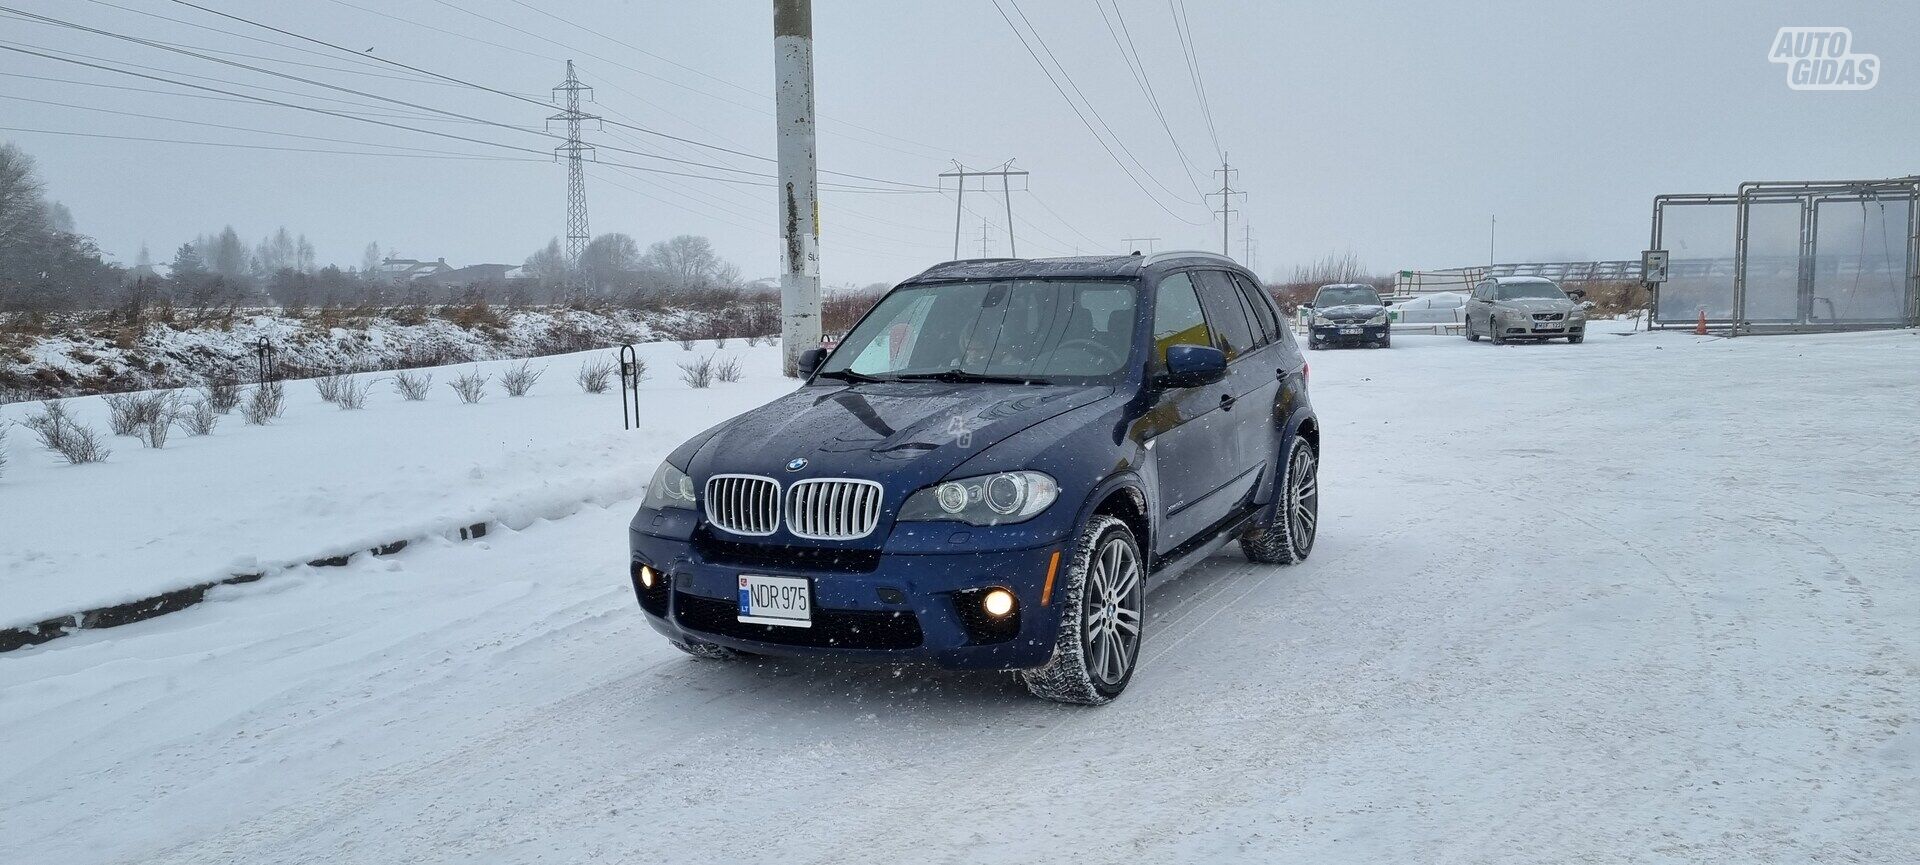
[0,339,793,627]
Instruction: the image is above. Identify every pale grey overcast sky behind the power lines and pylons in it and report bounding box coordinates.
[0,0,1920,284]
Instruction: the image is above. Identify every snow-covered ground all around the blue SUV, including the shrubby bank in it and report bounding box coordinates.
[0,322,1920,863]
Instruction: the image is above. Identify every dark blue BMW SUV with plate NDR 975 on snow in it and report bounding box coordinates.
[630,253,1319,704]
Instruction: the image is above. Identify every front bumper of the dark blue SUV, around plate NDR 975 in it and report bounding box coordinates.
[630,529,1068,669]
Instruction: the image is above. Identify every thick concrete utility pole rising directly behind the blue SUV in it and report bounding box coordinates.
[774,0,820,376]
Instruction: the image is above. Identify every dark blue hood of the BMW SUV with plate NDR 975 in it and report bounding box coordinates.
[687,382,1114,495]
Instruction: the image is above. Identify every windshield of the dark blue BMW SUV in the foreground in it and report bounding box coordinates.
[820,280,1137,382]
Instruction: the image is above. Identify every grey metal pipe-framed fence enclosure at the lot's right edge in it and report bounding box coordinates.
[1651,176,1920,336]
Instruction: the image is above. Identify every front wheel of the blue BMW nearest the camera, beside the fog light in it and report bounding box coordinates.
[1020,516,1146,706]
